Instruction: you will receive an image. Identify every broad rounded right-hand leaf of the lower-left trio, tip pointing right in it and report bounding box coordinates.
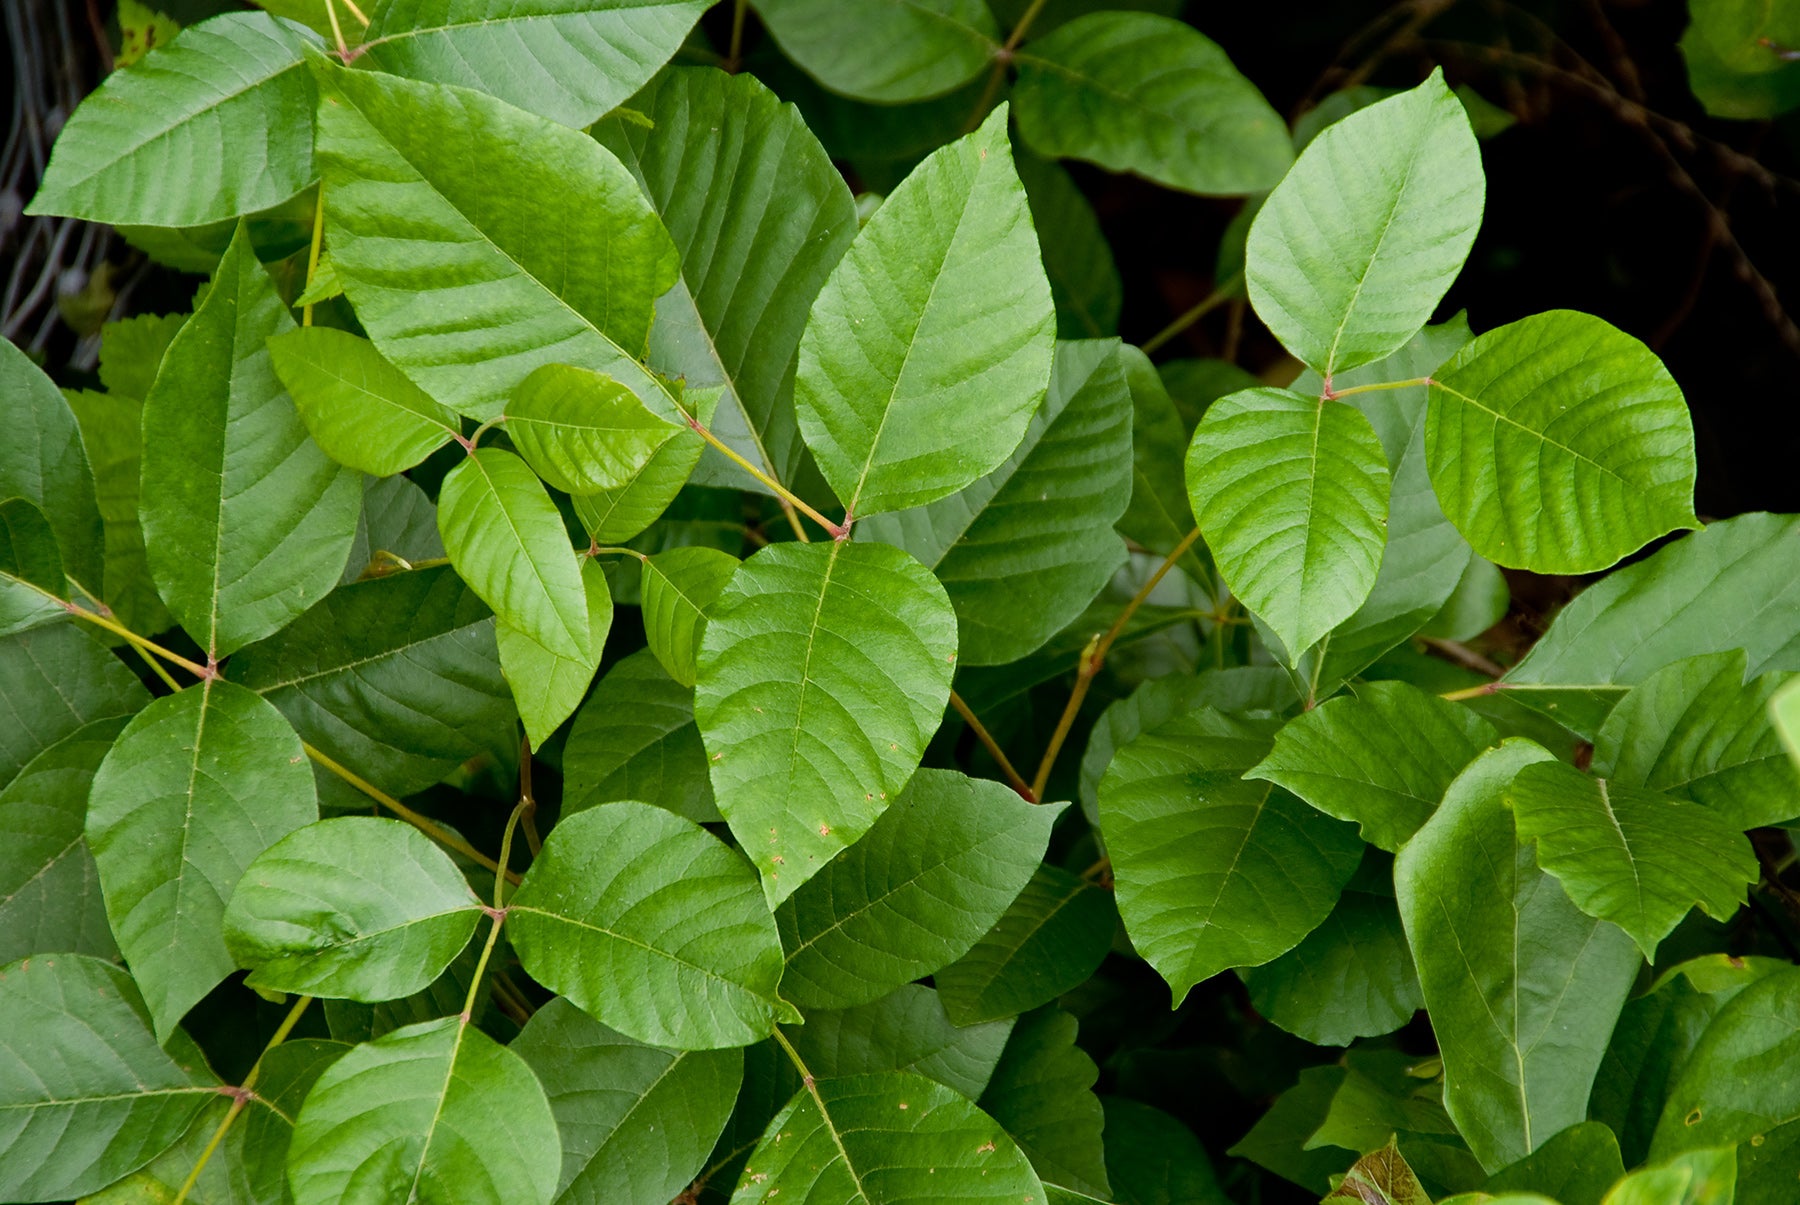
[508,802,790,1050]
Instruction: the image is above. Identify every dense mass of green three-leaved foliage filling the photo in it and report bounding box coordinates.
[0,0,1800,1205]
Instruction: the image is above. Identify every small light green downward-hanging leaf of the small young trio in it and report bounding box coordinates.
[437,448,596,661]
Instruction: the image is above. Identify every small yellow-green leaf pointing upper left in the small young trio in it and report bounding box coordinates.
[268,326,461,477]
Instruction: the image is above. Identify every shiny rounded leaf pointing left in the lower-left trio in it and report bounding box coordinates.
[223,816,482,1003]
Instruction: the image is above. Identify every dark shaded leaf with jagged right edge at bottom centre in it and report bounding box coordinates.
[981,1007,1111,1198]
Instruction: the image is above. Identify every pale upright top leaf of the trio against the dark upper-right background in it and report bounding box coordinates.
[1246,72,1487,380]
